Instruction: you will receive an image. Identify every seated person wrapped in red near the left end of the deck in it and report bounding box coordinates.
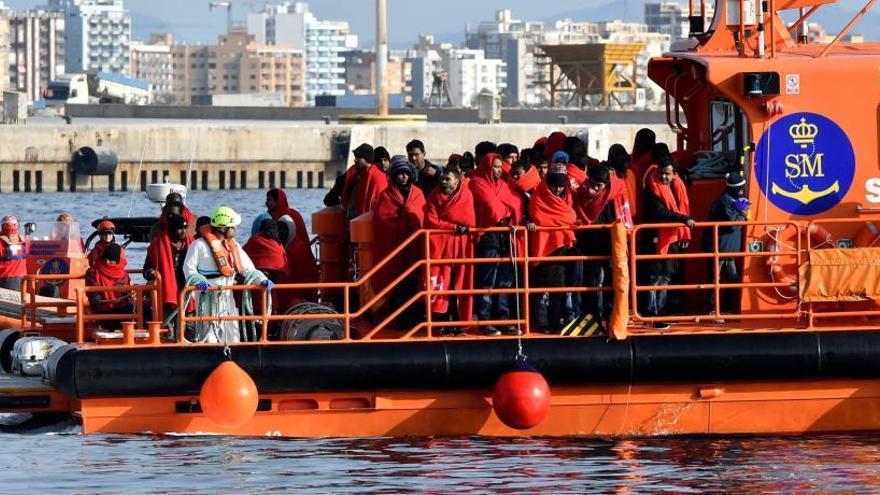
[85,243,134,330]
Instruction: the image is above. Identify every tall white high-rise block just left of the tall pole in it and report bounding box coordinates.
[247,2,357,105]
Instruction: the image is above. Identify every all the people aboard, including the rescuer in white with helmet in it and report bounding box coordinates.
[0,129,749,342]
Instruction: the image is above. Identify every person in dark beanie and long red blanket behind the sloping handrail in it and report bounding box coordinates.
[371,155,425,322]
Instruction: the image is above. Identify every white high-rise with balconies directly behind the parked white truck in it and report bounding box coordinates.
[49,0,131,75]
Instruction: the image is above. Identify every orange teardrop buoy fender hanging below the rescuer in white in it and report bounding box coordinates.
[199,361,260,428]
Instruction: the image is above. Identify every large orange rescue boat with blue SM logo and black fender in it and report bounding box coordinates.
[0,0,880,437]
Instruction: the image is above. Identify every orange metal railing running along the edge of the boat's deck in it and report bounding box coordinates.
[69,220,880,345]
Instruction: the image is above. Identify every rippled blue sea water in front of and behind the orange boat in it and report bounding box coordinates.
[0,190,880,494]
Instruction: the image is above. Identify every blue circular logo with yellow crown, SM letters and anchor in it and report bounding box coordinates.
[755,112,856,215]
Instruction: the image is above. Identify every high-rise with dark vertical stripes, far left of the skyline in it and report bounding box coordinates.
[9,10,65,101]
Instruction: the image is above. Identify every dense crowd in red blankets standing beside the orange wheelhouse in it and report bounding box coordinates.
[316,129,749,335]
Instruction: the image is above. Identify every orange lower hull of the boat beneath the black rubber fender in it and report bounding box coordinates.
[81,380,880,437]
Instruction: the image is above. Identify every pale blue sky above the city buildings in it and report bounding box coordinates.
[5,0,880,48]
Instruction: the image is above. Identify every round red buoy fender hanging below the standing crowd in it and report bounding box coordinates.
[492,369,550,430]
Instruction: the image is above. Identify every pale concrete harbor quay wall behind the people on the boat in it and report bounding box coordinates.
[0,120,674,193]
